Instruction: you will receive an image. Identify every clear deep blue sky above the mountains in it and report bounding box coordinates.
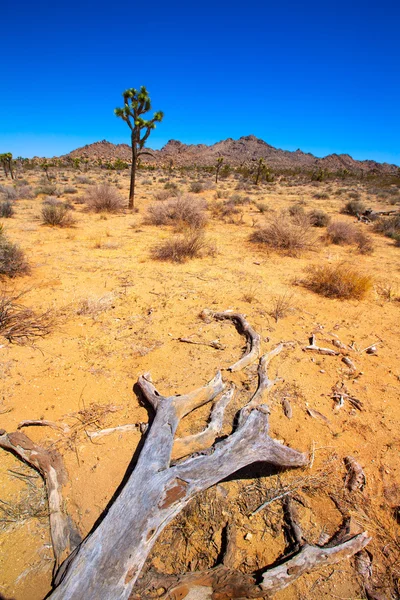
[0,0,400,164]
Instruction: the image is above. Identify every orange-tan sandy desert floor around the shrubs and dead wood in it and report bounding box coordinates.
[0,169,400,600]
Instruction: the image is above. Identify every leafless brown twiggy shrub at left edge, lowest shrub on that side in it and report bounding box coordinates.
[0,290,55,345]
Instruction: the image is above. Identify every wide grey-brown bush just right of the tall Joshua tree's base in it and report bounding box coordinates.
[145,195,207,229]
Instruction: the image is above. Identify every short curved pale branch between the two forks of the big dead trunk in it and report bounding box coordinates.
[172,386,235,460]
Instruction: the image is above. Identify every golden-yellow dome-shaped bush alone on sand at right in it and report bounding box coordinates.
[304,263,372,300]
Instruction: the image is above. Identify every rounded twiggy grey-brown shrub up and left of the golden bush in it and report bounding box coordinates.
[250,213,314,256]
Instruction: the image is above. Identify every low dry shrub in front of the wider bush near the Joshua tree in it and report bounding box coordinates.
[151,230,215,263]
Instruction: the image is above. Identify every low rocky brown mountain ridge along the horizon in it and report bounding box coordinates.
[62,135,398,173]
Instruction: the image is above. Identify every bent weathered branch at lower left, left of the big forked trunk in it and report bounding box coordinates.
[0,429,80,570]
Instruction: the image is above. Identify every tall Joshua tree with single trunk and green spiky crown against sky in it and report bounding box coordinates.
[114,86,164,209]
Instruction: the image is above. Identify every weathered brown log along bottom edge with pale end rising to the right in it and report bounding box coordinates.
[131,532,371,600]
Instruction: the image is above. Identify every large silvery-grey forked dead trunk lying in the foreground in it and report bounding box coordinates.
[51,356,307,600]
